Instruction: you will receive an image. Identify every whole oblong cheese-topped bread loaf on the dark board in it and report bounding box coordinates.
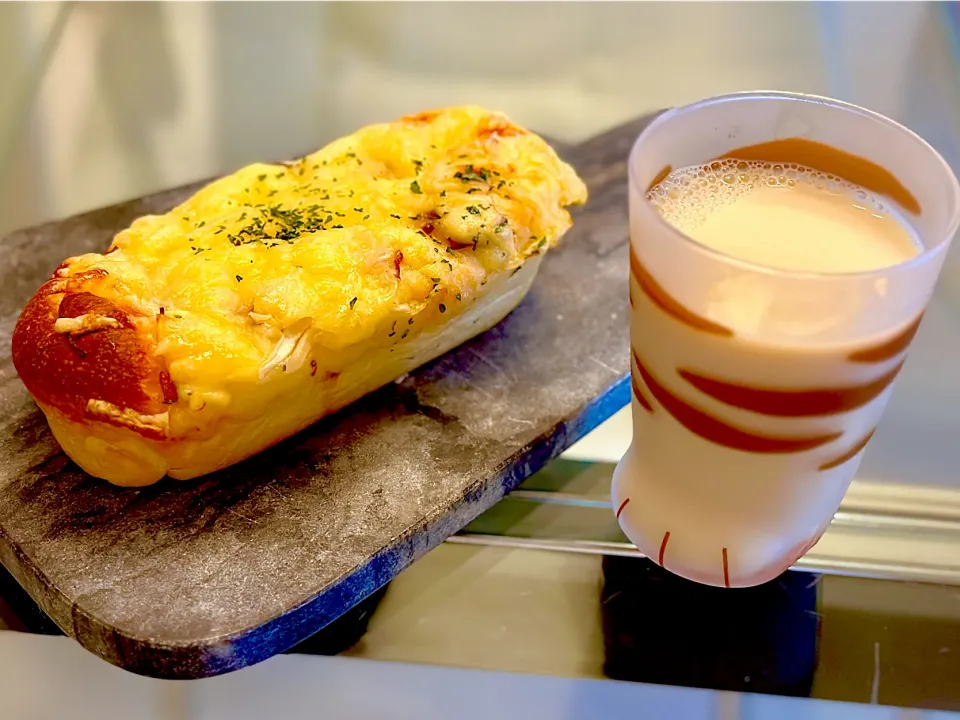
[13,107,587,486]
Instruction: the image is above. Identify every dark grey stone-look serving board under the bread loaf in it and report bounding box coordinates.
[0,112,645,678]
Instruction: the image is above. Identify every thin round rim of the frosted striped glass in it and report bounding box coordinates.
[627,90,960,280]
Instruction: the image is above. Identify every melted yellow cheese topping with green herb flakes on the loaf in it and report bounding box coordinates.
[67,107,586,424]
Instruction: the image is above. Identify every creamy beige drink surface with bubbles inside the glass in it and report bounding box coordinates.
[647,159,922,272]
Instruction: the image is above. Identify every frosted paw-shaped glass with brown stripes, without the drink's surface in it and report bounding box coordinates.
[612,92,960,587]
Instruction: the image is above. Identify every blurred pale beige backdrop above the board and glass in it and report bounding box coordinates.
[7,2,960,239]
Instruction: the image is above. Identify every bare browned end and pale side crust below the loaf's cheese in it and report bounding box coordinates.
[22,256,542,486]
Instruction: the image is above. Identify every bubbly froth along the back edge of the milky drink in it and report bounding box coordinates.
[647,158,886,232]
